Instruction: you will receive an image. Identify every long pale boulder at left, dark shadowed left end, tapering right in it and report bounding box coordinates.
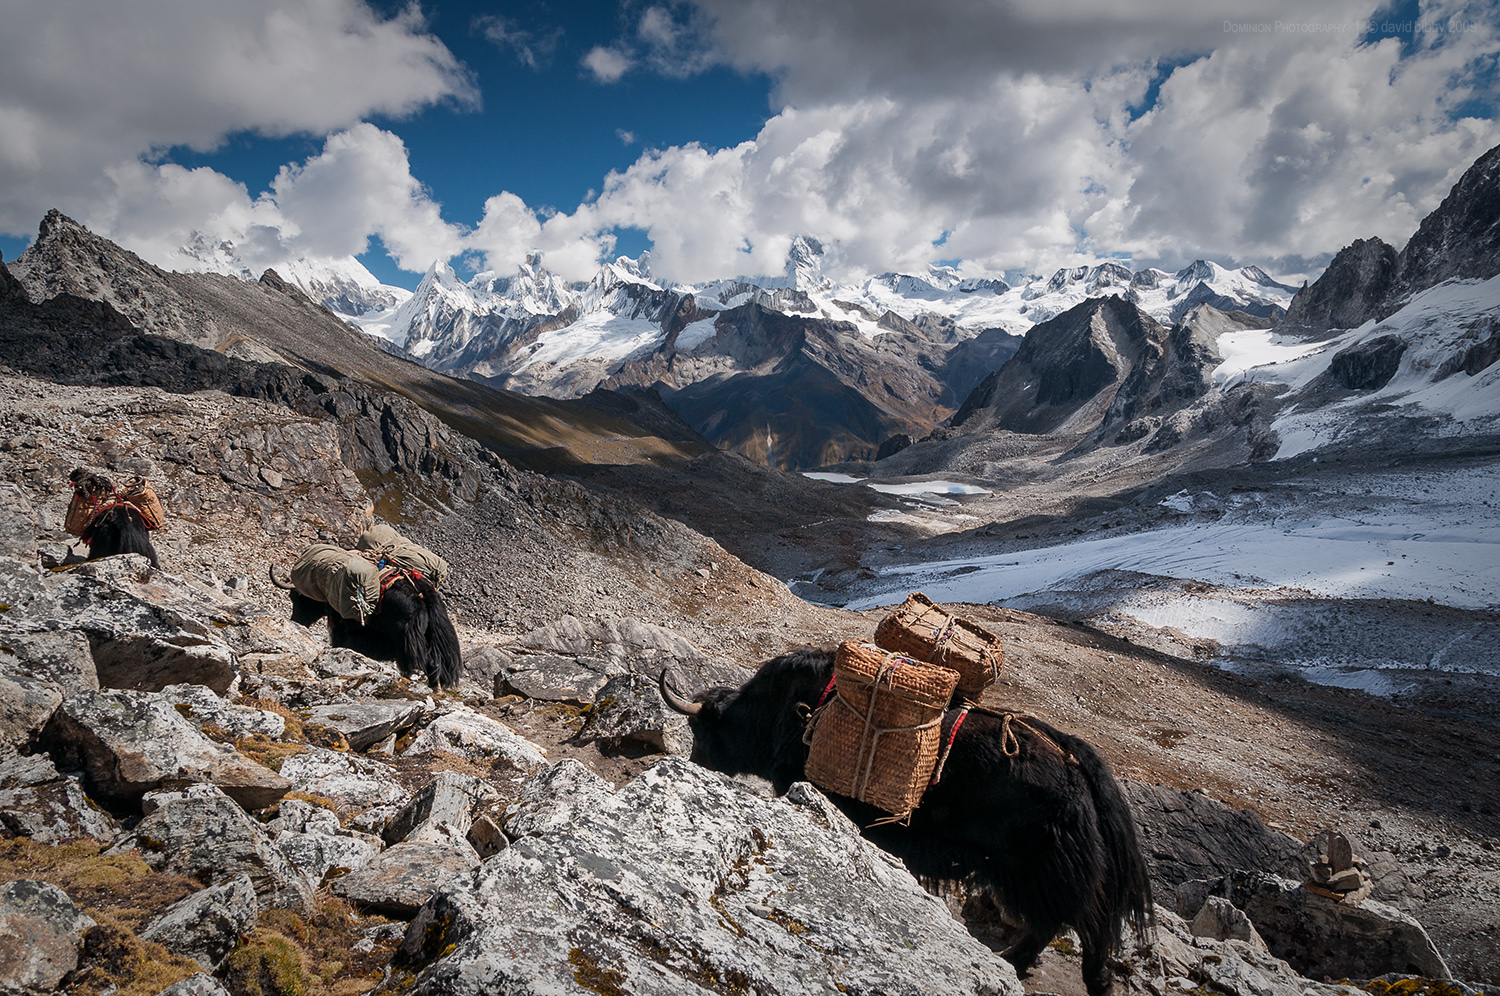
[44,689,291,810]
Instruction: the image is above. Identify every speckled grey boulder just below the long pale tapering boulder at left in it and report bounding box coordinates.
[105,792,312,908]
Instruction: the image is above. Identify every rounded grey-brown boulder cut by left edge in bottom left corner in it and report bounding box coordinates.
[0,879,95,996]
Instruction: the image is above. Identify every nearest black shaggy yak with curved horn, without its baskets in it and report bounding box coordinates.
[660,648,1152,996]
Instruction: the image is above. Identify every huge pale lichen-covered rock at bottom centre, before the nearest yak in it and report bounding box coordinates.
[402,759,1022,996]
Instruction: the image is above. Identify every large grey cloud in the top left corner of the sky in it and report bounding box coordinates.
[0,0,479,234]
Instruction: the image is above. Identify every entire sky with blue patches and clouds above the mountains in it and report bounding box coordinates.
[0,0,1500,287]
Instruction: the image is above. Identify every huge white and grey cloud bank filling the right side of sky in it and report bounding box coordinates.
[537,0,1500,281]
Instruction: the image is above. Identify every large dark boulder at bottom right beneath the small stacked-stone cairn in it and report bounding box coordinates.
[1179,872,1452,980]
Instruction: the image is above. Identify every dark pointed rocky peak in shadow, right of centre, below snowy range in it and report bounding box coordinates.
[953,297,1167,434]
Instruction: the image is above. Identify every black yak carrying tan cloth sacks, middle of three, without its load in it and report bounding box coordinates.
[270,566,464,689]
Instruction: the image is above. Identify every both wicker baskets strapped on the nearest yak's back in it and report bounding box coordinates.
[807,593,1004,819]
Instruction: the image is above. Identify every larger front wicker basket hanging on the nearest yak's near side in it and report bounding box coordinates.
[807,641,959,818]
